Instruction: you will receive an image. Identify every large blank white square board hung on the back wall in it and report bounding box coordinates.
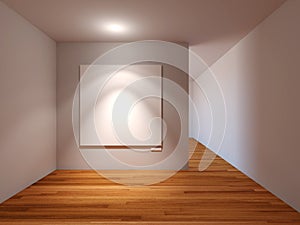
[79,64,163,148]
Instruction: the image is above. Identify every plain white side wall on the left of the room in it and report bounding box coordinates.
[0,2,56,202]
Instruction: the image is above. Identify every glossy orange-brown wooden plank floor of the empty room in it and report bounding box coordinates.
[0,140,300,225]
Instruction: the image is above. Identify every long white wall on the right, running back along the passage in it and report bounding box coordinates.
[192,0,300,211]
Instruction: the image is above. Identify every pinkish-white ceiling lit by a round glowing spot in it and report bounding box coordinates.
[2,0,284,64]
